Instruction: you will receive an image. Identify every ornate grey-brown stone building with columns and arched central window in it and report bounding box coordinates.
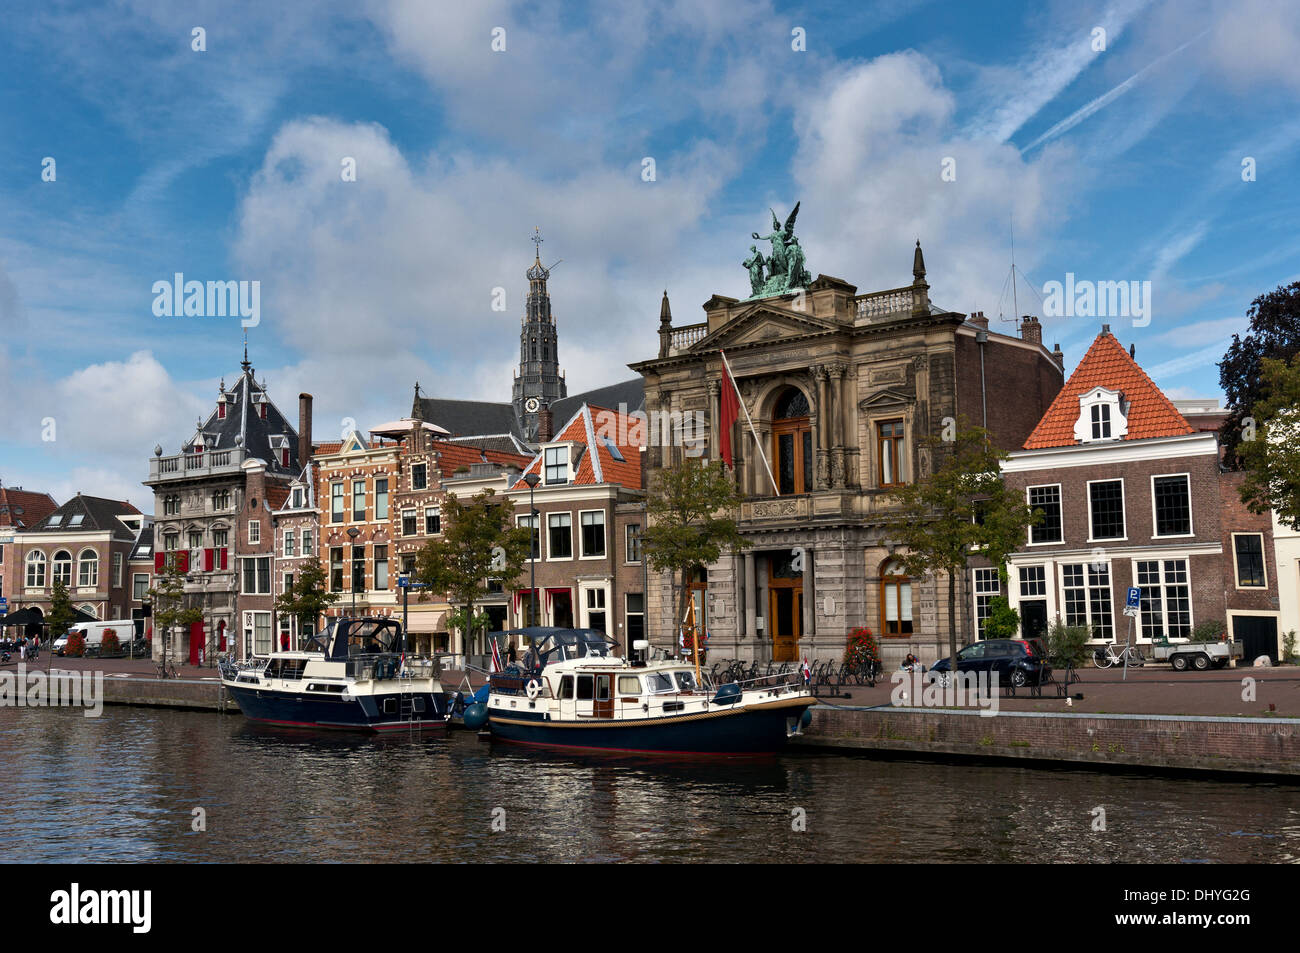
[631,243,1063,662]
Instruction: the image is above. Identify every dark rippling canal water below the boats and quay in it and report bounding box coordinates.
[0,707,1300,863]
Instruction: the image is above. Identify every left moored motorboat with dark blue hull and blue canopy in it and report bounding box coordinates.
[221,619,447,732]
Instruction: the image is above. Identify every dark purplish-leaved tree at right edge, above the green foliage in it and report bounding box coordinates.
[1218,281,1300,468]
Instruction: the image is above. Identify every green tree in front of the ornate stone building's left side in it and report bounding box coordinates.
[641,458,749,642]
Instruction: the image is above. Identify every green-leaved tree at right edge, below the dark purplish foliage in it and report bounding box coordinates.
[1238,358,1300,529]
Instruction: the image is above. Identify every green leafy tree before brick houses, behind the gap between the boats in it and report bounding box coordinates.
[415,489,533,649]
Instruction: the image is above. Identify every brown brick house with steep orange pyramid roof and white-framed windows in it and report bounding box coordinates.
[993,325,1278,654]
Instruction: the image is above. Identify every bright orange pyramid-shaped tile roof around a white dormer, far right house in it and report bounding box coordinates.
[1024,332,1195,450]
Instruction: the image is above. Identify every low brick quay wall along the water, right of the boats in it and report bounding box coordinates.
[800,705,1300,779]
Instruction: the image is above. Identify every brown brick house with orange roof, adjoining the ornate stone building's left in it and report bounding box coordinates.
[507,404,645,651]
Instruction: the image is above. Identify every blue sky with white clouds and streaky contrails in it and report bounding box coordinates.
[0,0,1300,512]
